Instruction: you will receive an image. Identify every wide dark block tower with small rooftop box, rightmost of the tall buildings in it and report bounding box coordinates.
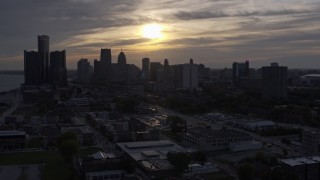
[262,63,288,99]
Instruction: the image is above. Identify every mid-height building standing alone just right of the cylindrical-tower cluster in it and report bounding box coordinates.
[77,59,91,83]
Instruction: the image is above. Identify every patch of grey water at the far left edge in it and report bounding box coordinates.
[0,75,24,92]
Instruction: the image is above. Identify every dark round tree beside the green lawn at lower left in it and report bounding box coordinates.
[57,132,79,161]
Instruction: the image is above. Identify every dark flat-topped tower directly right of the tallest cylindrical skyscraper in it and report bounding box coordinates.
[50,50,67,86]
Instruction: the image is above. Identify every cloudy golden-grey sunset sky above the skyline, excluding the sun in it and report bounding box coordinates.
[0,0,320,70]
